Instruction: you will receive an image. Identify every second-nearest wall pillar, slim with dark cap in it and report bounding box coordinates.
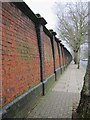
[49,30,57,81]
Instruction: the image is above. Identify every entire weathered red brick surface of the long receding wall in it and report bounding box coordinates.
[0,2,71,106]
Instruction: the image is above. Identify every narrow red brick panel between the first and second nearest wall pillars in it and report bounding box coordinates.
[43,33,54,78]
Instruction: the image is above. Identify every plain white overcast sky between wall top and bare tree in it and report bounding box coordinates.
[24,0,89,51]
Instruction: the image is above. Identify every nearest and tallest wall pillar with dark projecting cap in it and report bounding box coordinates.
[36,14,47,95]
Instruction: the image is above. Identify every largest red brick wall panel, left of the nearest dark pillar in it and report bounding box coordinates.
[2,3,40,105]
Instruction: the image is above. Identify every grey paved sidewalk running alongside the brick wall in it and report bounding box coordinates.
[27,62,86,118]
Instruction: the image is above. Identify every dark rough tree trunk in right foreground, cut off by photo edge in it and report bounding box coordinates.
[77,56,90,118]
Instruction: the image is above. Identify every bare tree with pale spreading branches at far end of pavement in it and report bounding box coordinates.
[57,2,88,68]
